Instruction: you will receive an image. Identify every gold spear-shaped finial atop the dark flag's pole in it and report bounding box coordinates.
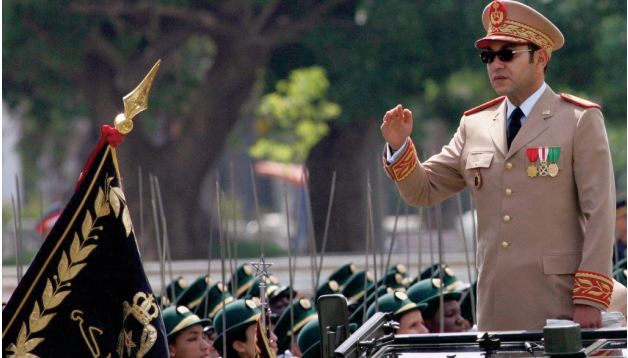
[114,60,161,134]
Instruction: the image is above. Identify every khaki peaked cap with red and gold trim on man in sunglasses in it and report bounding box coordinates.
[475,0,565,52]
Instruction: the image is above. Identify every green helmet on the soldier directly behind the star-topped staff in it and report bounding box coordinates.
[214,299,262,352]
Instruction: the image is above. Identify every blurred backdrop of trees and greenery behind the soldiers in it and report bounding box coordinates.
[2,0,626,272]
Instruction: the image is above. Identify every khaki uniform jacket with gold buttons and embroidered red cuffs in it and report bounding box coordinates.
[385,87,615,330]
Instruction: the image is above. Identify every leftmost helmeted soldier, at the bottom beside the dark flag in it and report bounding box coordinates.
[162,306,218,358]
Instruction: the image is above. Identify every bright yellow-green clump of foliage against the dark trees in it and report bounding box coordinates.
[250,67,340,163]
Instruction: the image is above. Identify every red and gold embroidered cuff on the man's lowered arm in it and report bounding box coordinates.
[573,270,613,307]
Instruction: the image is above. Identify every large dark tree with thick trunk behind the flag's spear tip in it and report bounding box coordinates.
[3,0,346,257]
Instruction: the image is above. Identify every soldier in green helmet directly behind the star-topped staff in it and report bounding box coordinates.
[214,299,277,358]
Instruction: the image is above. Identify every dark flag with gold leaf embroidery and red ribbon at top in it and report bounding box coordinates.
[2,126,168,357]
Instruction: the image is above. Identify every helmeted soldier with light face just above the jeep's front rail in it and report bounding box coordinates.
[366,291,429,334]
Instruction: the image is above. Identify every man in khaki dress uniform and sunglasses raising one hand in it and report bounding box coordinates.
[381,0,615,330]
